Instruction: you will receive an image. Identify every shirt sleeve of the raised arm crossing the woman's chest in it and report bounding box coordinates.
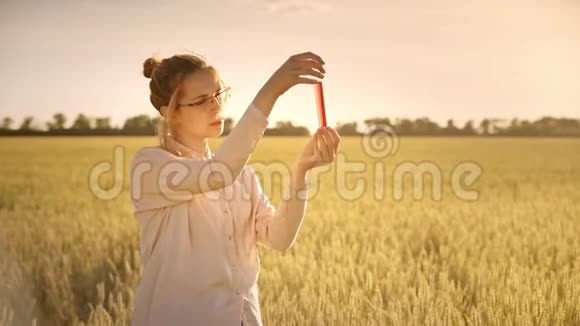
[130,102,268,212]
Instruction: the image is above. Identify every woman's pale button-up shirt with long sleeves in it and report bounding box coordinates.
[131,103,307,326]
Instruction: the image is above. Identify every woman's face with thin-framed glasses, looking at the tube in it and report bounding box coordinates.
[165,69,224,139]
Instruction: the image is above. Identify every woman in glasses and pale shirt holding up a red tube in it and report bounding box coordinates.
[131,52,340,326]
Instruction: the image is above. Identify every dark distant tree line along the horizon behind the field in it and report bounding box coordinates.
[0,113,580,137]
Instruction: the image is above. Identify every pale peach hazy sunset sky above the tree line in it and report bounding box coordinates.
[0,0,580,130]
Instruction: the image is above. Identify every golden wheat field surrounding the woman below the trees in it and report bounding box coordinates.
[0,137,580,326]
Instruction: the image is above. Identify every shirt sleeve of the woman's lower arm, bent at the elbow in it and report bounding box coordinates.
[249,168,308,252]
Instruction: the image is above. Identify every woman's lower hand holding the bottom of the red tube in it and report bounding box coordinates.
[294,127,341,172]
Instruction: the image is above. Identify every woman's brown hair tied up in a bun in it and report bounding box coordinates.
[143,53,223,148]
